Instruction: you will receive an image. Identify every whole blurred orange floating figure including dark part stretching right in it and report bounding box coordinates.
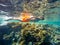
[7,12,44,22]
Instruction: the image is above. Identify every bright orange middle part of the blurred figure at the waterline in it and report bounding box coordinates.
[14,12,34,22]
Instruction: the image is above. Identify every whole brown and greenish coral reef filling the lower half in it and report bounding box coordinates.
[0,22,60,45]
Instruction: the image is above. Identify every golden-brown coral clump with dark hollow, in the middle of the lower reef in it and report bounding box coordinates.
[20,24,49,45]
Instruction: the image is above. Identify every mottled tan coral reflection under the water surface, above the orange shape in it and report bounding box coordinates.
[23,0,58,16]
